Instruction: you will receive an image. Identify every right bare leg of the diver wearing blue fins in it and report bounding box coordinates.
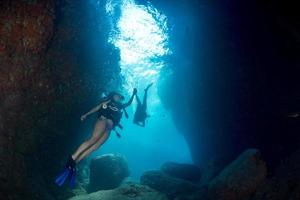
[77,120,112,162]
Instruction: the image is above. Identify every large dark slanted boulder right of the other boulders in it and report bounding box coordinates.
[208,149,267,200]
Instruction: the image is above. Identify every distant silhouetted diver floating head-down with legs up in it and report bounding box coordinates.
[133,83,153,127]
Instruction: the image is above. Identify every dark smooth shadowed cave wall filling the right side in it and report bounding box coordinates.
[152,0,300,167]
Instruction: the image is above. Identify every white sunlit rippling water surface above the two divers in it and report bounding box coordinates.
[107,0,170,92]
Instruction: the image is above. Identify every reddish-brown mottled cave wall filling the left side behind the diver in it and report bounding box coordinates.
[0,0,120,199]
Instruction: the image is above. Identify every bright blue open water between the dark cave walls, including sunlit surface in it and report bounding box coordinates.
[93,0,192,180]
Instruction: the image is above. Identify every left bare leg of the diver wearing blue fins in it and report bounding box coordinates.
[72,119,106,163]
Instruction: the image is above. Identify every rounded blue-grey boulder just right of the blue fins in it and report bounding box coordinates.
[88,154,129,192]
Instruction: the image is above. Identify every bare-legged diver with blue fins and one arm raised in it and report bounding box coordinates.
[55,89,137,188]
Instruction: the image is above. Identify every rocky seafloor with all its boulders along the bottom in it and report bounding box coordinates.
[69,149,300,200]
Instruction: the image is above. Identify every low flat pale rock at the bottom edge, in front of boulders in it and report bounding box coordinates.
[69,184,167,200]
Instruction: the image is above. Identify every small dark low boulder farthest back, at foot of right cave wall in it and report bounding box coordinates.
[161,162,201,182]
